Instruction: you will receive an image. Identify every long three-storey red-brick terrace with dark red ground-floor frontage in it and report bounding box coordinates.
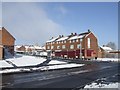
[46,30,98,59]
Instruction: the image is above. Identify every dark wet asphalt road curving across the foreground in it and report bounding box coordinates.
[2,60,119,90]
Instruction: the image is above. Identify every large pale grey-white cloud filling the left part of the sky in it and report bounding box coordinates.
[3,3,65,44]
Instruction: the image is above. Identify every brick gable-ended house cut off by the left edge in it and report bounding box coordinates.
[0,27,15,59]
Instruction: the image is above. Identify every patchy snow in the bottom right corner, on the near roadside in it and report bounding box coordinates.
[84,82,120,88]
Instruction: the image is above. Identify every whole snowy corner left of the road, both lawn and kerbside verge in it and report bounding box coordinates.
[0,55,84,73]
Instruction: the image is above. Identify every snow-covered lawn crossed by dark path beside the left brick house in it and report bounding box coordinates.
[0,55,46,68]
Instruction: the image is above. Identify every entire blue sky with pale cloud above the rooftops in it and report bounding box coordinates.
[0,2,118,46]
